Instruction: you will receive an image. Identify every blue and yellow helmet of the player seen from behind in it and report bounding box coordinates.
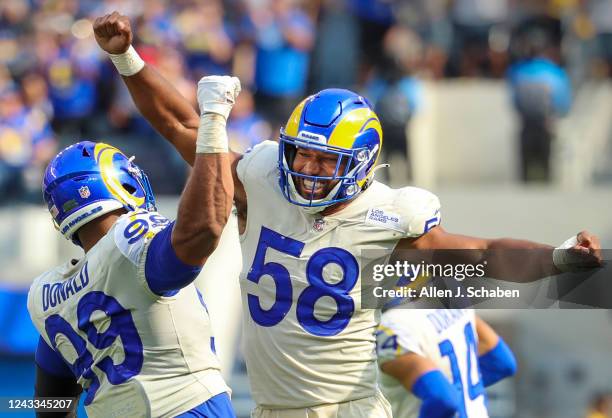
[42,141,155,245]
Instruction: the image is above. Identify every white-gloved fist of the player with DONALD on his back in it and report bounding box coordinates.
[198,75,241,120]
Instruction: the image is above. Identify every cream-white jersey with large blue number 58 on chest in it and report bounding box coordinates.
[238,141,440,409]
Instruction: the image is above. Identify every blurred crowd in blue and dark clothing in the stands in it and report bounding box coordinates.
[0,0,612,203]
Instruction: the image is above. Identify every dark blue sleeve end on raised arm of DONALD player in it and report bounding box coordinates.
[145,222,202,296]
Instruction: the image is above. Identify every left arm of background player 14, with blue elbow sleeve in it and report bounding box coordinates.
[380,353,459,418]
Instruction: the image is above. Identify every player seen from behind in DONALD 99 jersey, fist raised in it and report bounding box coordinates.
[28,76,240,418]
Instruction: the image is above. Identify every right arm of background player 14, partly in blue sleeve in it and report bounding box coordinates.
[476,317,517,387]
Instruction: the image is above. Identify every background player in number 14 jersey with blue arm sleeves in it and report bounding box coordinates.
[376,305,516,418]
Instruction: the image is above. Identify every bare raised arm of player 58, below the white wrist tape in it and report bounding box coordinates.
[122,65,200,166]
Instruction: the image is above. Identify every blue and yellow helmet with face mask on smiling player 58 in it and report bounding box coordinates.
[278,89,382,213]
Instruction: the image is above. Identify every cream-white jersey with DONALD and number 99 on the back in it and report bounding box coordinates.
[28,212,228,417]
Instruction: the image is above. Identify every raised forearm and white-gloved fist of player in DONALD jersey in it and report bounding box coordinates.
[172,76,240,266]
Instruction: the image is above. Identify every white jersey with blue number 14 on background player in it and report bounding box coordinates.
[376,308,489,418]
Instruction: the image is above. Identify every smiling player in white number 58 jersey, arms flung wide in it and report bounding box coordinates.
[94,12,599,418]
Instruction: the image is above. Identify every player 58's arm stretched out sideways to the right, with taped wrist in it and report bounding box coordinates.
[398,226,602,282]
